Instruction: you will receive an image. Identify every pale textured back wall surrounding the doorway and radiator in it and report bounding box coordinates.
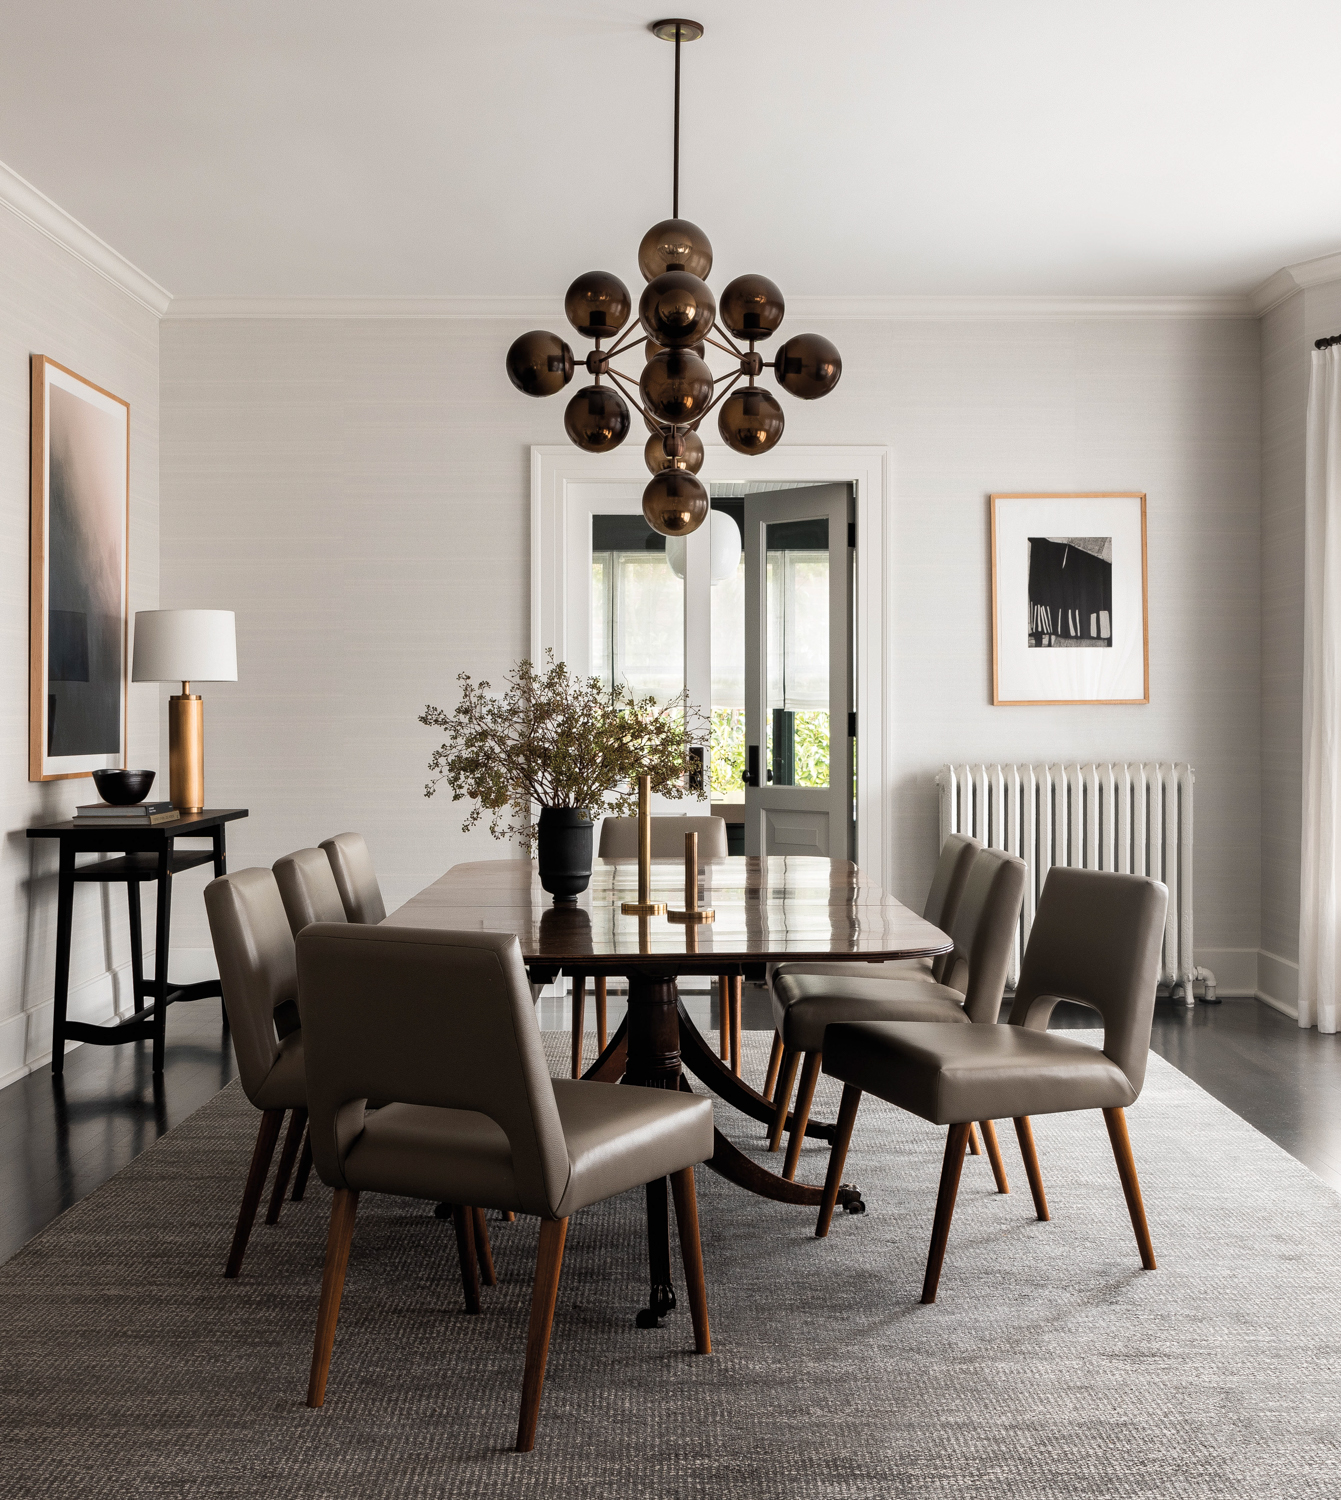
[162,306,1262,993]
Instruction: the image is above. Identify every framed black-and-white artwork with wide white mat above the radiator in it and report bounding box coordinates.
[992,492,1151,705]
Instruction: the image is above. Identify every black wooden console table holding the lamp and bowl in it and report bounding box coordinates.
[29,807,248,1077]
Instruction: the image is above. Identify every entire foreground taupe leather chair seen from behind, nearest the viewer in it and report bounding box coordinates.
[297,923,713,1452]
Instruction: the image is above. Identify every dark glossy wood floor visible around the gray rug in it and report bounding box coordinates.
[0,1001,1341,1260]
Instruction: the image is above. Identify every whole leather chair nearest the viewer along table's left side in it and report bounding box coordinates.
[206,870,308,1278]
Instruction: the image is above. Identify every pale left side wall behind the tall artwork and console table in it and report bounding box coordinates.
[0,204,159,1085]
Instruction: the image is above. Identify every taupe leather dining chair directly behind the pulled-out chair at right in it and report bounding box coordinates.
[768,848,1028,1193]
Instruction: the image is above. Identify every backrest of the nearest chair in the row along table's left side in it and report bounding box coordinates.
[206,870,299,1104]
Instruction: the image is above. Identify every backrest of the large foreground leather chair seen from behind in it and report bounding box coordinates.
[297,923,570,1218]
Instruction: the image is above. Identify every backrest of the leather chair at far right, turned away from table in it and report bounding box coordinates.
[1011,867,1169,1094]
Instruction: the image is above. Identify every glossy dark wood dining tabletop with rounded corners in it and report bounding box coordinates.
[387,855,951,974]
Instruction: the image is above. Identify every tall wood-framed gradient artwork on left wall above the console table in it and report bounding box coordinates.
[29,354,131,782]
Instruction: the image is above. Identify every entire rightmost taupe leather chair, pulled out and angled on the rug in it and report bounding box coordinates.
[815,867,1169,1302]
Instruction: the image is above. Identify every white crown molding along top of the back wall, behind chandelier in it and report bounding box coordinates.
[167,296,1256,324]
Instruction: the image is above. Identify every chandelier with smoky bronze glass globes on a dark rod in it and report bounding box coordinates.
[507,18,843,537]
